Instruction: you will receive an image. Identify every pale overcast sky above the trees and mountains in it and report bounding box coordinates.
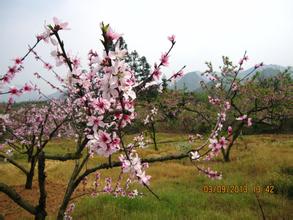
[0,0,293,94]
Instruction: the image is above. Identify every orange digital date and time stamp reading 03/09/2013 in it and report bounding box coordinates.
[202,185,275,193]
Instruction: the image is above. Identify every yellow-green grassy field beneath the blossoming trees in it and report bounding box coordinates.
[0,134,293,219]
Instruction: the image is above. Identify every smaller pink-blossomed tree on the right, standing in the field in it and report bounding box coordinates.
[183,55,293,161]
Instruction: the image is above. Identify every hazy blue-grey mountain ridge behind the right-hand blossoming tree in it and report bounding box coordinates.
[169,64,293,91]
